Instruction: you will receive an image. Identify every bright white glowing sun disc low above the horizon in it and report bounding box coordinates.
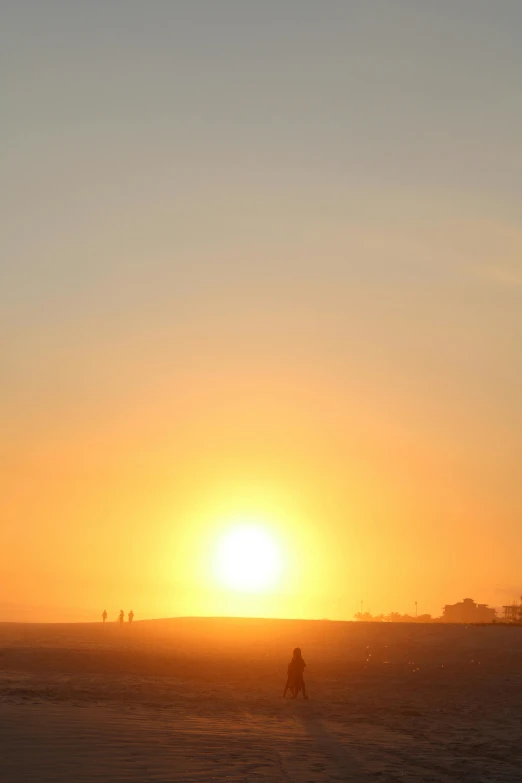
[216,524,282,592]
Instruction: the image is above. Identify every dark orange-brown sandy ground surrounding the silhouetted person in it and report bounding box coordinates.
[0,620,522,783]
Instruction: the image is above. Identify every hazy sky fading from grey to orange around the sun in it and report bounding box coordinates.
[0,0,522,620]
